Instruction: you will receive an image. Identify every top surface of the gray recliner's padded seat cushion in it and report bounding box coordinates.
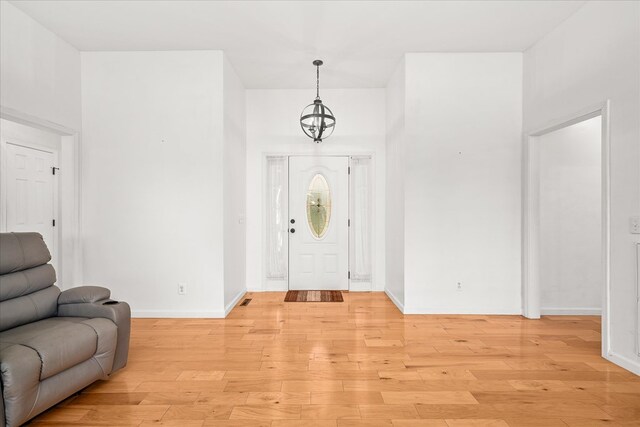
[0,317,101,381]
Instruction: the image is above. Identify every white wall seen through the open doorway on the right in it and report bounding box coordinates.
[535,116,603,314]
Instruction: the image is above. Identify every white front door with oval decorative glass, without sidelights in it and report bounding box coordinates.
[289,156,349,290]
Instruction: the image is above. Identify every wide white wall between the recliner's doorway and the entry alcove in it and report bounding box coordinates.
[82,51,224,317]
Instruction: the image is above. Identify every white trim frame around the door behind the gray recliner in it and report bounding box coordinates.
[0,138,60,271]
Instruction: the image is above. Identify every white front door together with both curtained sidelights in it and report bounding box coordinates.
[263,154,374,291]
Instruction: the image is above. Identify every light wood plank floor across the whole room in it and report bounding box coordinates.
[28,293,640,427]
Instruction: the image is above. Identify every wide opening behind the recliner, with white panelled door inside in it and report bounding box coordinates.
[0,111,82,289]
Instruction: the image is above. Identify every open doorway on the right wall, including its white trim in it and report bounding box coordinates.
[523,104,609,357]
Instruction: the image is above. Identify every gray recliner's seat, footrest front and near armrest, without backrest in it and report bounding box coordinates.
[0,317,118,427]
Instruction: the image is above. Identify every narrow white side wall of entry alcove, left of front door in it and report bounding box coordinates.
[222,56,247,312]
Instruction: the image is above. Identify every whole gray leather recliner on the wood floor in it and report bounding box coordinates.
[0,233,131,427]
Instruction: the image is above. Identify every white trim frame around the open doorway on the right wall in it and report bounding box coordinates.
[522,100,611,358]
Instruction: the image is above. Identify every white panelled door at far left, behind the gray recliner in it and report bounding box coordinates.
[4,143,55,256]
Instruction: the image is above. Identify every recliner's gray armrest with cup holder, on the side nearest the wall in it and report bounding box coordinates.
[58,298,131,373]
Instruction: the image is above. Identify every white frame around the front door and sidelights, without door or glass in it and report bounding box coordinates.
[260,151,377,292]
